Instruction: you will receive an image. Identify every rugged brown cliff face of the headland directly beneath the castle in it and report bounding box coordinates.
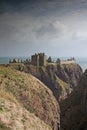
[27,64,82,100]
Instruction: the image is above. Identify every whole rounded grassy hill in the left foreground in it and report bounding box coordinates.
[0,66,60,130]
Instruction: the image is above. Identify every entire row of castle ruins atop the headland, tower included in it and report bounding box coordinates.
[9,53,76,67]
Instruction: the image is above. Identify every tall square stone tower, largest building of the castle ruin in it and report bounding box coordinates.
[31,53,46,66]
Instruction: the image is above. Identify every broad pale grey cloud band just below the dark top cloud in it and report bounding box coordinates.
[0,4,87,44]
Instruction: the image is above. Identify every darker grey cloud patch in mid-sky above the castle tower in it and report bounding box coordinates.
[33,20,68,40]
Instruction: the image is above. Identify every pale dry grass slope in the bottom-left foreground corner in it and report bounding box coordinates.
[0,97,51,130]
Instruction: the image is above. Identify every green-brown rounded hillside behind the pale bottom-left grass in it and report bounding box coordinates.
[0,66,59,130]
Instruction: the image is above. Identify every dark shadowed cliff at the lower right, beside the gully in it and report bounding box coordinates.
[60,70,87,130]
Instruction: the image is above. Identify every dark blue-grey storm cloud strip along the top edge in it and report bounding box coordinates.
[0,0,87,16]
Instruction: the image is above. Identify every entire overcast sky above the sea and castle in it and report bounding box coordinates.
[0,0,87,57]
